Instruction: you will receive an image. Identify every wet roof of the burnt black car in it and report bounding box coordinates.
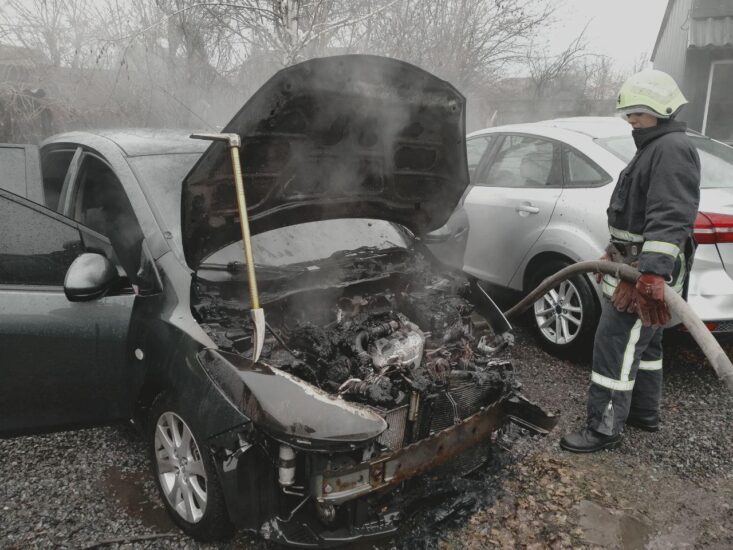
[45,128,210,157]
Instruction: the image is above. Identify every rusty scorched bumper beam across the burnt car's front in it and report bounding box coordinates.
[311,394,557,505]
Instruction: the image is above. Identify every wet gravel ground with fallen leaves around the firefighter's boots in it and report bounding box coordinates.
[443,328,733,549]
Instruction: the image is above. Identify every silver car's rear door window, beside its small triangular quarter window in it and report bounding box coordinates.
[476,135,561,187]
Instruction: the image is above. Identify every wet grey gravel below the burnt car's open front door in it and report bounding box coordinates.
[0,425,266,549]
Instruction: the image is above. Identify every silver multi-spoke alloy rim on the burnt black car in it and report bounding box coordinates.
[155,412,208,523]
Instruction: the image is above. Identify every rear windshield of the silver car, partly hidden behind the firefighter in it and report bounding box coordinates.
[596,135,733,189]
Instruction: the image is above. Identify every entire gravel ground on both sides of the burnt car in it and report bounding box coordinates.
[0,327,733,548]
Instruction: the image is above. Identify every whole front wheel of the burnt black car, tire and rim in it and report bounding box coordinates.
[146,394,234,542]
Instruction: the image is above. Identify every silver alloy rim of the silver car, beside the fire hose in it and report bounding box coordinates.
[534,280,583,345]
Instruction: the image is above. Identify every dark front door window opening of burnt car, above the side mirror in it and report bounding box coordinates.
[71,155,143,283]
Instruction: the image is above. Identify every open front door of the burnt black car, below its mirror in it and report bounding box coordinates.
[0,191,134,436]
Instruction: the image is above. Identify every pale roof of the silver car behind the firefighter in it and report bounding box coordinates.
[469,116,631,139]
